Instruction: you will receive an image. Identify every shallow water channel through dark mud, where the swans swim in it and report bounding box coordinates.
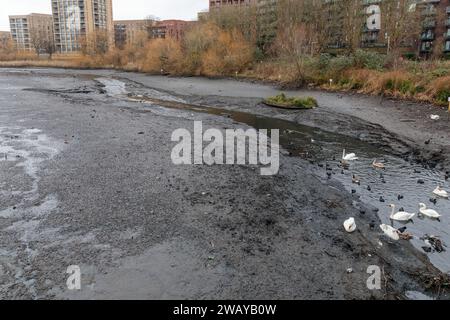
[100,79,450,272]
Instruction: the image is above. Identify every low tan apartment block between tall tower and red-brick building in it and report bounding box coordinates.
[114,20,149,48]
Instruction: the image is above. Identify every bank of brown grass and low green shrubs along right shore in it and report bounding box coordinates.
[246,52,450,105]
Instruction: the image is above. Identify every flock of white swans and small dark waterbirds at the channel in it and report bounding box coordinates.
[341,149,449,252]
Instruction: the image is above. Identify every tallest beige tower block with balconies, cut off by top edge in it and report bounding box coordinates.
[52,0,114,53]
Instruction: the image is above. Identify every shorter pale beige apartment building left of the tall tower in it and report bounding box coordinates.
[9,13,53,51]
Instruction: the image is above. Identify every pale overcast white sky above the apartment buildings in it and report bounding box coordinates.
[0,0,208,31]
